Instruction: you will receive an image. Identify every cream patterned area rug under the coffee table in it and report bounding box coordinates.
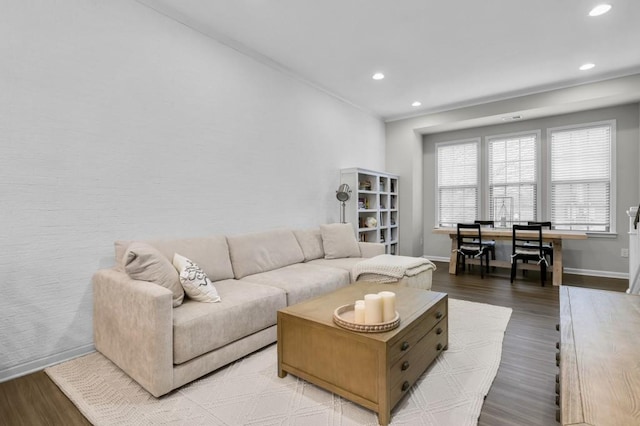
[45,299,511,426]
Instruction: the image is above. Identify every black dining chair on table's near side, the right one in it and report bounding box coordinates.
[511,225,548,286]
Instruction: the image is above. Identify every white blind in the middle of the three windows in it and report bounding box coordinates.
[487,133,538,228]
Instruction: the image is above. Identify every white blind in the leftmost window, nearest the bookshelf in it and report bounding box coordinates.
[436,140,479,226]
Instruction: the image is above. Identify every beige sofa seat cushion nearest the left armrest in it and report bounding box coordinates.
[173,280,287,364]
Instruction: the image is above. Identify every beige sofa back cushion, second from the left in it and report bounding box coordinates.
[227,229,304,279]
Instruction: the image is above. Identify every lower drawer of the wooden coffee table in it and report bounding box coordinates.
[389,317,449,407]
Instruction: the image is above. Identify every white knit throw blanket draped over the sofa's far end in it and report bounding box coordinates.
[352,254,436,282]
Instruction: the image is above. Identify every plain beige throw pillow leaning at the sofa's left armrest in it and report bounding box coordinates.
[122,242,184,308]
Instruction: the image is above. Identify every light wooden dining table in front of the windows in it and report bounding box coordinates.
[433,227,587,286]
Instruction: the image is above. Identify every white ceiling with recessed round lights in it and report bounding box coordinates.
[138,0,640,121]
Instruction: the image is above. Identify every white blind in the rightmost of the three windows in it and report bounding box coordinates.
[550,123,613,232]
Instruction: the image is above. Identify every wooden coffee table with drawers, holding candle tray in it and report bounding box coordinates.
[278,282,449,425]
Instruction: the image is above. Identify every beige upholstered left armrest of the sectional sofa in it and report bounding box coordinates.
[93,269,173,397]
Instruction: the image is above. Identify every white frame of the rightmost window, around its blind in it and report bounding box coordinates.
[545,119,617,236]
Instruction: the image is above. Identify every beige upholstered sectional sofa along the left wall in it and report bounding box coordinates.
[93,224,384,397]
